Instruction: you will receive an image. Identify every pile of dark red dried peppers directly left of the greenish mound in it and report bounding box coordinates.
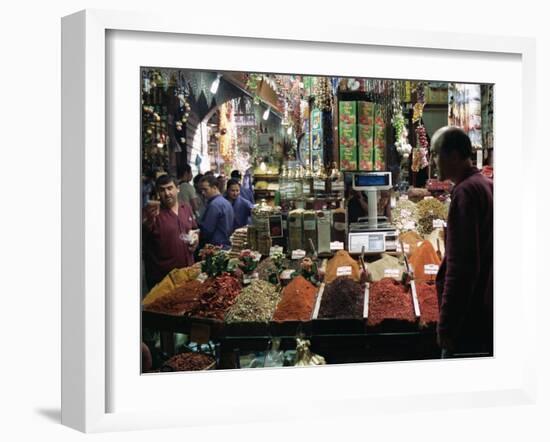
[189,274,242,321]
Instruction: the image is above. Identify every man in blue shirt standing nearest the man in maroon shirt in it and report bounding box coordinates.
[199,175,234,249]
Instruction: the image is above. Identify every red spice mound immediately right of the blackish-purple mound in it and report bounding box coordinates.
[367,278,415,326]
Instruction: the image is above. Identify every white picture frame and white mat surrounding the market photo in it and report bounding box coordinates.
[62,10,536,432]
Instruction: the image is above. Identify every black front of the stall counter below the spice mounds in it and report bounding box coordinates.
[142,311,440,368]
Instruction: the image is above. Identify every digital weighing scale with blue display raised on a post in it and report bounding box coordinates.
[348,172,397,253]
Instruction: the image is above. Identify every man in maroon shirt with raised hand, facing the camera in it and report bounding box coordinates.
[142,175,198,289]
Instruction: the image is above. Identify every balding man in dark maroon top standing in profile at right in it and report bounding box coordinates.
[432,127,493,357]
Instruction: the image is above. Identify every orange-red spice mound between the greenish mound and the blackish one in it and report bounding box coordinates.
[273,276,317,322]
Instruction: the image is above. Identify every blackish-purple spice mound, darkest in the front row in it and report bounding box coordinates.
[318,276,365,319]
